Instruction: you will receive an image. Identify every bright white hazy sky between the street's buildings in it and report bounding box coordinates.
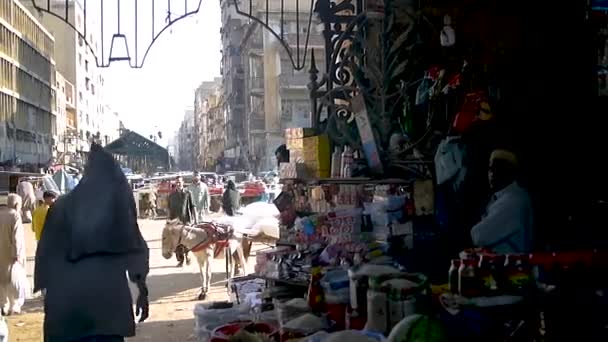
[103,0,221,145]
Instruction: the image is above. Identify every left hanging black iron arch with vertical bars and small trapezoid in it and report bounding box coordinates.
[31,0,203,69]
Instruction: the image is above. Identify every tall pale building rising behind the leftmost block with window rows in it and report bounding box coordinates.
[28,0,105,163]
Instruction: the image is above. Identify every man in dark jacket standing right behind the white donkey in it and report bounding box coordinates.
[169,177,196,267]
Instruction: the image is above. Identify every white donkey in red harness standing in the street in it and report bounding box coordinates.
[162,220,246,300]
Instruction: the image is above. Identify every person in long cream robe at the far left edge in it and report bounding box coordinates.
[0,194,26,314]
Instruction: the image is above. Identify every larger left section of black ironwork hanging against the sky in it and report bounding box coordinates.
[31,0,203,68]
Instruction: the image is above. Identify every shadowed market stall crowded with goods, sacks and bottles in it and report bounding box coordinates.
[190,0,608,342]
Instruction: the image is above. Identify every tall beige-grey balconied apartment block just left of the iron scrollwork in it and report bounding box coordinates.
[222,0,325,171]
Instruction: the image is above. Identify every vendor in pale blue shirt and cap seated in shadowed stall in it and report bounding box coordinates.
[471,150,533,254]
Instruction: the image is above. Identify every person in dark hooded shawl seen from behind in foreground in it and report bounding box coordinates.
[34,144,149,342]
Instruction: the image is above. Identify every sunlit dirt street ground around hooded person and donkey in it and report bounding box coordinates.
[8,220,247,342]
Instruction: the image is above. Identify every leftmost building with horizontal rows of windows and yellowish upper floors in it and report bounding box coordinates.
[0,0,56,164]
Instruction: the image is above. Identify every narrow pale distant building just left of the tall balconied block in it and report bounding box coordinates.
[194,77,222,170]
